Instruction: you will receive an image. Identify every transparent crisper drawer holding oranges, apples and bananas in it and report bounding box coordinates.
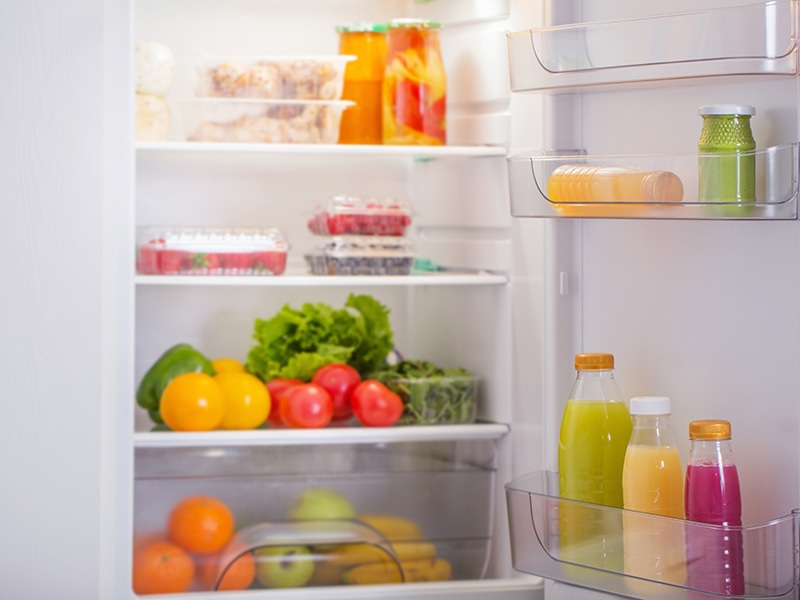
[133,440,496,591]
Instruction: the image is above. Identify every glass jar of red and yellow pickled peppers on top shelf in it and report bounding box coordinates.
[383,19,447,146]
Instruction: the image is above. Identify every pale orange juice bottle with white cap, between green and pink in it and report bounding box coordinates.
[622,396,686,587]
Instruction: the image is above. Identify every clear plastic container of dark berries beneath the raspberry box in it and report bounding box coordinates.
[305,236,414,275]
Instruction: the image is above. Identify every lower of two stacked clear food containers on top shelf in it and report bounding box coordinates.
[183,99,352,144]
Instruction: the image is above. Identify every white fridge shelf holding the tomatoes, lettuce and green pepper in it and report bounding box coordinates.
[133,423,509,448]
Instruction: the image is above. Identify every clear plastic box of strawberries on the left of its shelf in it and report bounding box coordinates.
[136,227,288,275]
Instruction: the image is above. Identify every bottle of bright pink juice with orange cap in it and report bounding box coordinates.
[684,421,744,595]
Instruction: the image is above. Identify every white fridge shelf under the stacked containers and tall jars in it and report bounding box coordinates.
[136,142,508,160]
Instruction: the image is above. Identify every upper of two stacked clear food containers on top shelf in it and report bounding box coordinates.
[195,55,355,100]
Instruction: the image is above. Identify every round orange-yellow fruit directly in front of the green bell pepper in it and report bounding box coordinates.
[160,373,225,431]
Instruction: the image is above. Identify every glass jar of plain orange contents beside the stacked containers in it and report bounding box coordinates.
[336,23,387,144]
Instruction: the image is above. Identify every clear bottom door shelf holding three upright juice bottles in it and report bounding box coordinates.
[506,471,800,600]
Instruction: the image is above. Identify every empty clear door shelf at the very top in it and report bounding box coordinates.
[508,0,798,92]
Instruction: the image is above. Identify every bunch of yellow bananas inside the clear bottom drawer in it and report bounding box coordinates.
[312,515,452,585]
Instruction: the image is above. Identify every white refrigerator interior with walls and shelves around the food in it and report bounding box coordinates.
[134,0,542,598]
